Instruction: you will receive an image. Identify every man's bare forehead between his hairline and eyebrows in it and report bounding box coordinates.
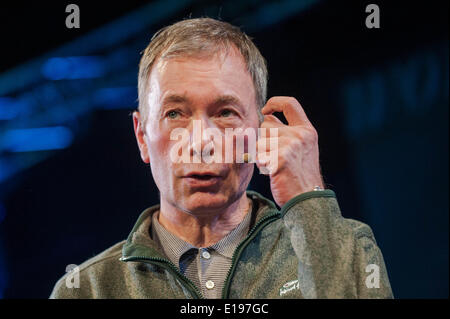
[149,47,255,103]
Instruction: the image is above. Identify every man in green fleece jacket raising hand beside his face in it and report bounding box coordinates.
[51,18,392,298]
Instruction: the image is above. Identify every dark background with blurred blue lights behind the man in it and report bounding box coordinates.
[0,0,449,298]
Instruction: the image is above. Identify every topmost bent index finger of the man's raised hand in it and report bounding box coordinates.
[261,96,311,125]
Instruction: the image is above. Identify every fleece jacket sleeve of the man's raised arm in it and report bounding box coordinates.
[281,190,393,298]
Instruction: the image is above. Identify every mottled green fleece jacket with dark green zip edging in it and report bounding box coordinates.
[50,190,393,298]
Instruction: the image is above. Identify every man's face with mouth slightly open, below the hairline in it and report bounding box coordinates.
[135,48,259,215]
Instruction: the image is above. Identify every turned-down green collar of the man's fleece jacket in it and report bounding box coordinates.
[121,190,279,260]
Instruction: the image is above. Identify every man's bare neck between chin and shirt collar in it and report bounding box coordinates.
[158,192,250,247]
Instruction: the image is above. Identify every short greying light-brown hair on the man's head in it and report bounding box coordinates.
[138,18,268,121]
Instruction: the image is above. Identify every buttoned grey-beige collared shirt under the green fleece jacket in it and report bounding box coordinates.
[151,200,253,299]
